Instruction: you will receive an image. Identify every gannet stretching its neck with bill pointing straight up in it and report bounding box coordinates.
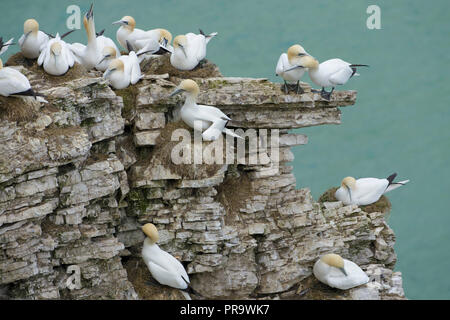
[70,4,119,70]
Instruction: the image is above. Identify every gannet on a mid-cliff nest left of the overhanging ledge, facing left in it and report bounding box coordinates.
[170,79,242,141]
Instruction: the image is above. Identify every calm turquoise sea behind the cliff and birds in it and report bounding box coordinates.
[0,0,450,299]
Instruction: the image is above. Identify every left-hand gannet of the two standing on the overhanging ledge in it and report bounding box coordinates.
[275,44,309,94]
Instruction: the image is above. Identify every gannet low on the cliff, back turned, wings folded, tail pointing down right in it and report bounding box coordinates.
[142,223,191,300]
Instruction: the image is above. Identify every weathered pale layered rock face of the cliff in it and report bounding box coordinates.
[0,57,404,299]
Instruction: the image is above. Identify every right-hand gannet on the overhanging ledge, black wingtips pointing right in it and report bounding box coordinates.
[291,56,368,100]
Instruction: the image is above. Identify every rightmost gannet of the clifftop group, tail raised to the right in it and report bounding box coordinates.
[170,30,217,70]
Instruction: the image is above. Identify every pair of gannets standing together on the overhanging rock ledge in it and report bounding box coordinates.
[276,45,368,100]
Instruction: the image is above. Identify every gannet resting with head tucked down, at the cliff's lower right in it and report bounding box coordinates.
[313,253,369,290]
